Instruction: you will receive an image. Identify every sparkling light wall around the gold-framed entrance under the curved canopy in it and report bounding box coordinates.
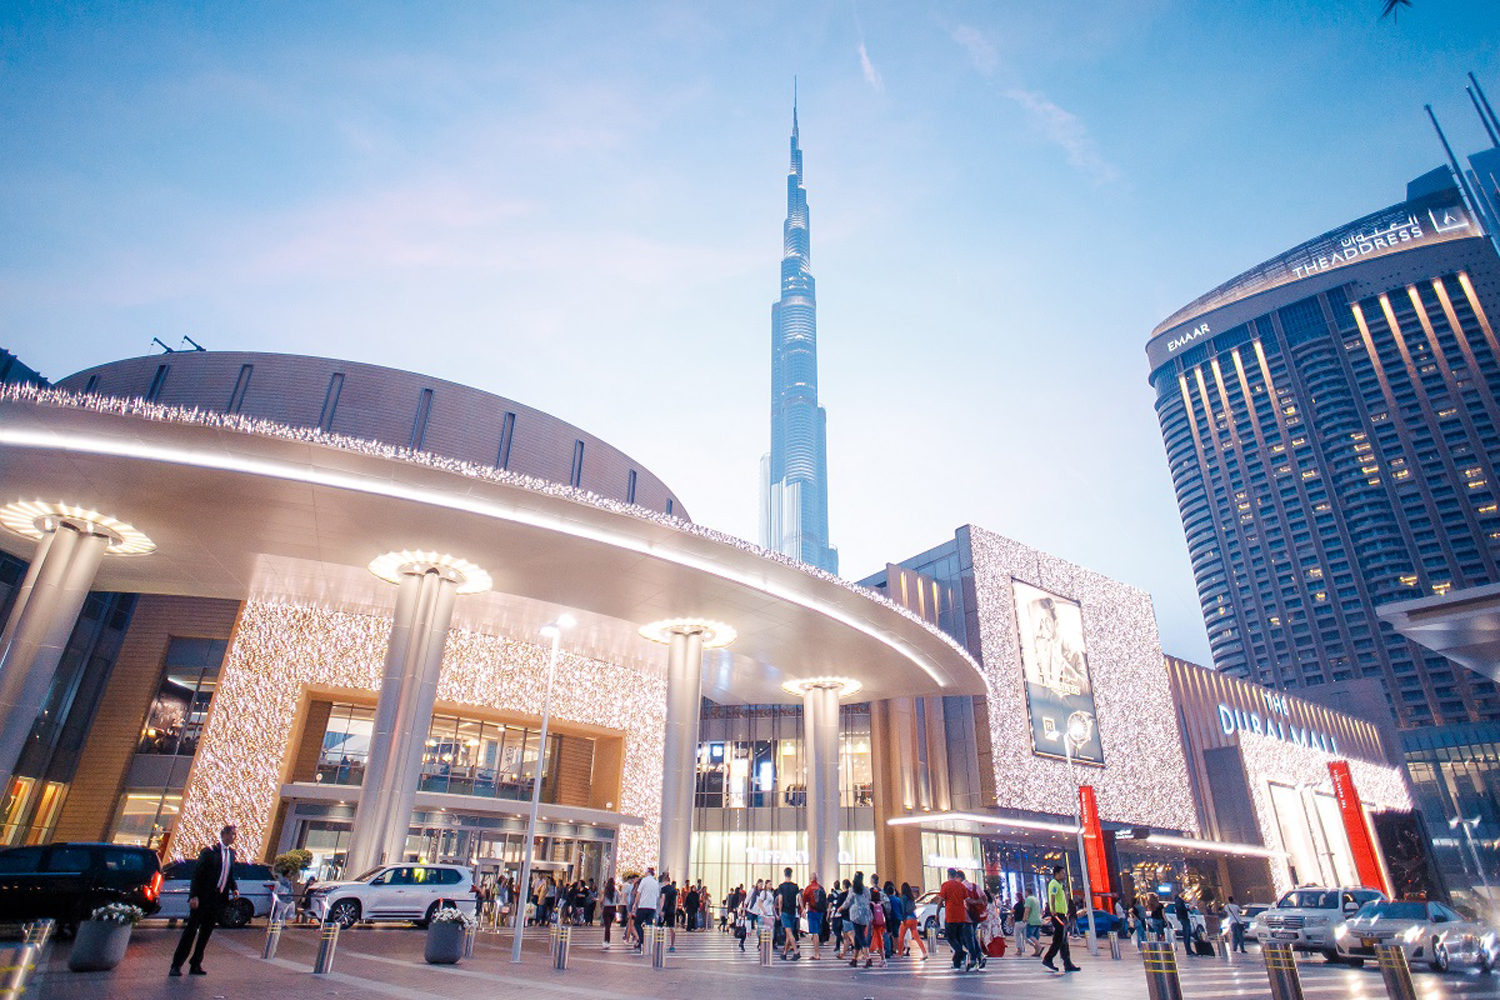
[176,601,666,870]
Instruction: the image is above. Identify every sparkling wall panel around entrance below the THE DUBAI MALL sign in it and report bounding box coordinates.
[1239,733,1413,895]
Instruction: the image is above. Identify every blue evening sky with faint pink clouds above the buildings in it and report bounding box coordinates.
[0,0,1500,663]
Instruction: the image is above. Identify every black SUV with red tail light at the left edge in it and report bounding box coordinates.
[0,843,162,937]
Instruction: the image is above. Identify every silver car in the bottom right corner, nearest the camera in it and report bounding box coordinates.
[1334,901,1500,972]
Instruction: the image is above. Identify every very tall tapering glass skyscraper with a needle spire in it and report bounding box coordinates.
[761,100,839,573]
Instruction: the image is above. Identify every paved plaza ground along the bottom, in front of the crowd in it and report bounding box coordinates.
[32,925,1500,1000]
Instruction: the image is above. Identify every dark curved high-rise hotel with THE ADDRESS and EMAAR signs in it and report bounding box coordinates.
[1146,168,1500,729]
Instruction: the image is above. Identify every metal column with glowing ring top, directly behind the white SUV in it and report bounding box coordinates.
[345,556,489,876]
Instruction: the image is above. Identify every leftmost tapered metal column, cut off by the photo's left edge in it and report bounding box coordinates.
[0,520,116,781]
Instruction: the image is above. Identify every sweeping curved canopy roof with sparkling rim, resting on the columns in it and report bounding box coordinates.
[0,387,984,703]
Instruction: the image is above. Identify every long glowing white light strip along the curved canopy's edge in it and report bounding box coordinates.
[0,427,983,688]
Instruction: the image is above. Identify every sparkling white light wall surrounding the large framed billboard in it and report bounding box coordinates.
[969,528,1197,832]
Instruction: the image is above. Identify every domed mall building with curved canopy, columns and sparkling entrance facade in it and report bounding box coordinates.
[0,352,983,877]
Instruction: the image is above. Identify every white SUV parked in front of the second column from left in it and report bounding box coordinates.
[309,864,476,928]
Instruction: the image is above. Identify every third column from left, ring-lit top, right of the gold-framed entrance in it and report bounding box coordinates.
[641,618,735,882]
